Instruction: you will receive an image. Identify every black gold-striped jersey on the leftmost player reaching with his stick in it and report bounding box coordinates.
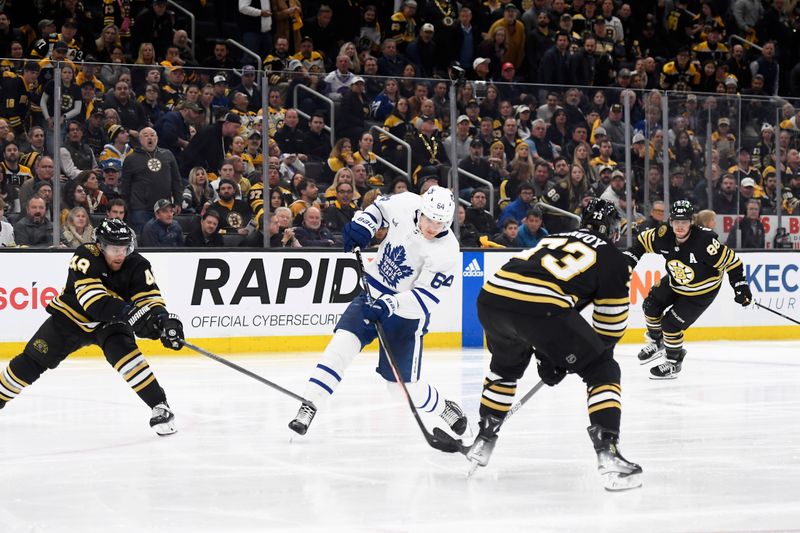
[46,244,166,332]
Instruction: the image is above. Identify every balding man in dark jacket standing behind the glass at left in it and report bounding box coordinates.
[122,128,183,232]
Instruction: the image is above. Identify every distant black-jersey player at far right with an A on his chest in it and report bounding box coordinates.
[625,200,753,379]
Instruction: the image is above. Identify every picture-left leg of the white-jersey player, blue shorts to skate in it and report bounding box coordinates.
[289,293,377,435]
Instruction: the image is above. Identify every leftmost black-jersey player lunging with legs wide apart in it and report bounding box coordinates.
[0,219,183,435]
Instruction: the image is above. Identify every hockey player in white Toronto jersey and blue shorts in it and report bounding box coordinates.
[289,186,467,435]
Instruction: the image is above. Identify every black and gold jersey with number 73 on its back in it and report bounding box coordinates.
[478,229,631,344]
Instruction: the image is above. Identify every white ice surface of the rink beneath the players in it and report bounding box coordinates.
[0,342,800,533]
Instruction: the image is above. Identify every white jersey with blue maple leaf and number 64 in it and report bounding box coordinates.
[353,192,460,319]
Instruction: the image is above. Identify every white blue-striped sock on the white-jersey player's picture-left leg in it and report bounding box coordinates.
[304,329,361,408]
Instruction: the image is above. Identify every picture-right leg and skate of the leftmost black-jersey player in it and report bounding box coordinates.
[95,324,177,436]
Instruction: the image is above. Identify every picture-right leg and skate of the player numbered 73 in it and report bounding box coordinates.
[578,348,642,490]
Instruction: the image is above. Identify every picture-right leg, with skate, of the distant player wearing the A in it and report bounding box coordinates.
[650,291,719,379]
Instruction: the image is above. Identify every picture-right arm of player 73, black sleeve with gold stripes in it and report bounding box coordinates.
[592,259,632,346]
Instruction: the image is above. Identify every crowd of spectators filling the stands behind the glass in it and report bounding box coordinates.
[0,0,800,247]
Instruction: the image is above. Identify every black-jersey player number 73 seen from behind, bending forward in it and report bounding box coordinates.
[467,199,642,490]
